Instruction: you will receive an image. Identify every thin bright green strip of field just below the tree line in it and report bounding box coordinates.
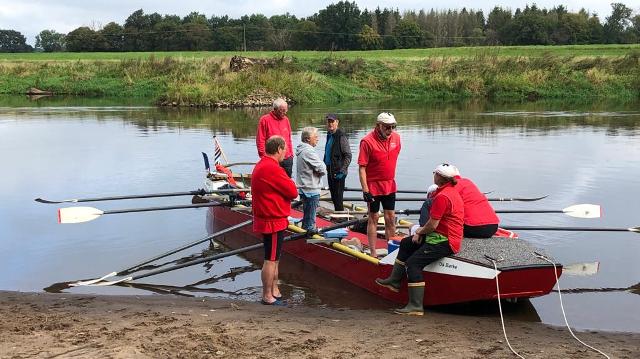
[0,44,640,61]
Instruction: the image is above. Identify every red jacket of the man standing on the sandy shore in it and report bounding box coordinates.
[251,156,298,233]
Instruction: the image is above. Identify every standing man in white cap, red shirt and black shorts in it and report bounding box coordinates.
[358,112,401,257]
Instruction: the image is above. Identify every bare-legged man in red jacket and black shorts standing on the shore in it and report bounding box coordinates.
[251,136,298,305]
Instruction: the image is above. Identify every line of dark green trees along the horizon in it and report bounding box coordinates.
[0,1,640,52]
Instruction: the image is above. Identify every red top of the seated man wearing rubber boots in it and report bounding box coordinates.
[429,183,464,253]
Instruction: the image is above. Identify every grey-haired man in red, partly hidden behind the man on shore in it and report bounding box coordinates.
[256,98,293,177]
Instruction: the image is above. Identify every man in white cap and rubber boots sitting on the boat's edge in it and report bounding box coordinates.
[376,164,464,315]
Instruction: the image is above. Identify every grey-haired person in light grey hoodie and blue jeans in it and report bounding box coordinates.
[296,127,327,231]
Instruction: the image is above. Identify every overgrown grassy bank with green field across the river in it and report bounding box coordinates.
[0,46,640,105]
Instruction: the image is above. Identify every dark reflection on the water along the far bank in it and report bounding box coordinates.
[0,98,640,139]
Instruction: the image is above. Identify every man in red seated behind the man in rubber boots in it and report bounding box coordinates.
[418,165,500,238]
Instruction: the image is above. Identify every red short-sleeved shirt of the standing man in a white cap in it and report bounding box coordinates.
[358,129,402,196]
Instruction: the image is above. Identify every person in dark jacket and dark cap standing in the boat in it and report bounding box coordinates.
[324,114,351,211]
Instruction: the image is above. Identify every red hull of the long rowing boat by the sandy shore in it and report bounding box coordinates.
[209,206,562,306]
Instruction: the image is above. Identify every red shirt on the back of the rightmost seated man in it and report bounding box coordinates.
[454,176,500,226]
